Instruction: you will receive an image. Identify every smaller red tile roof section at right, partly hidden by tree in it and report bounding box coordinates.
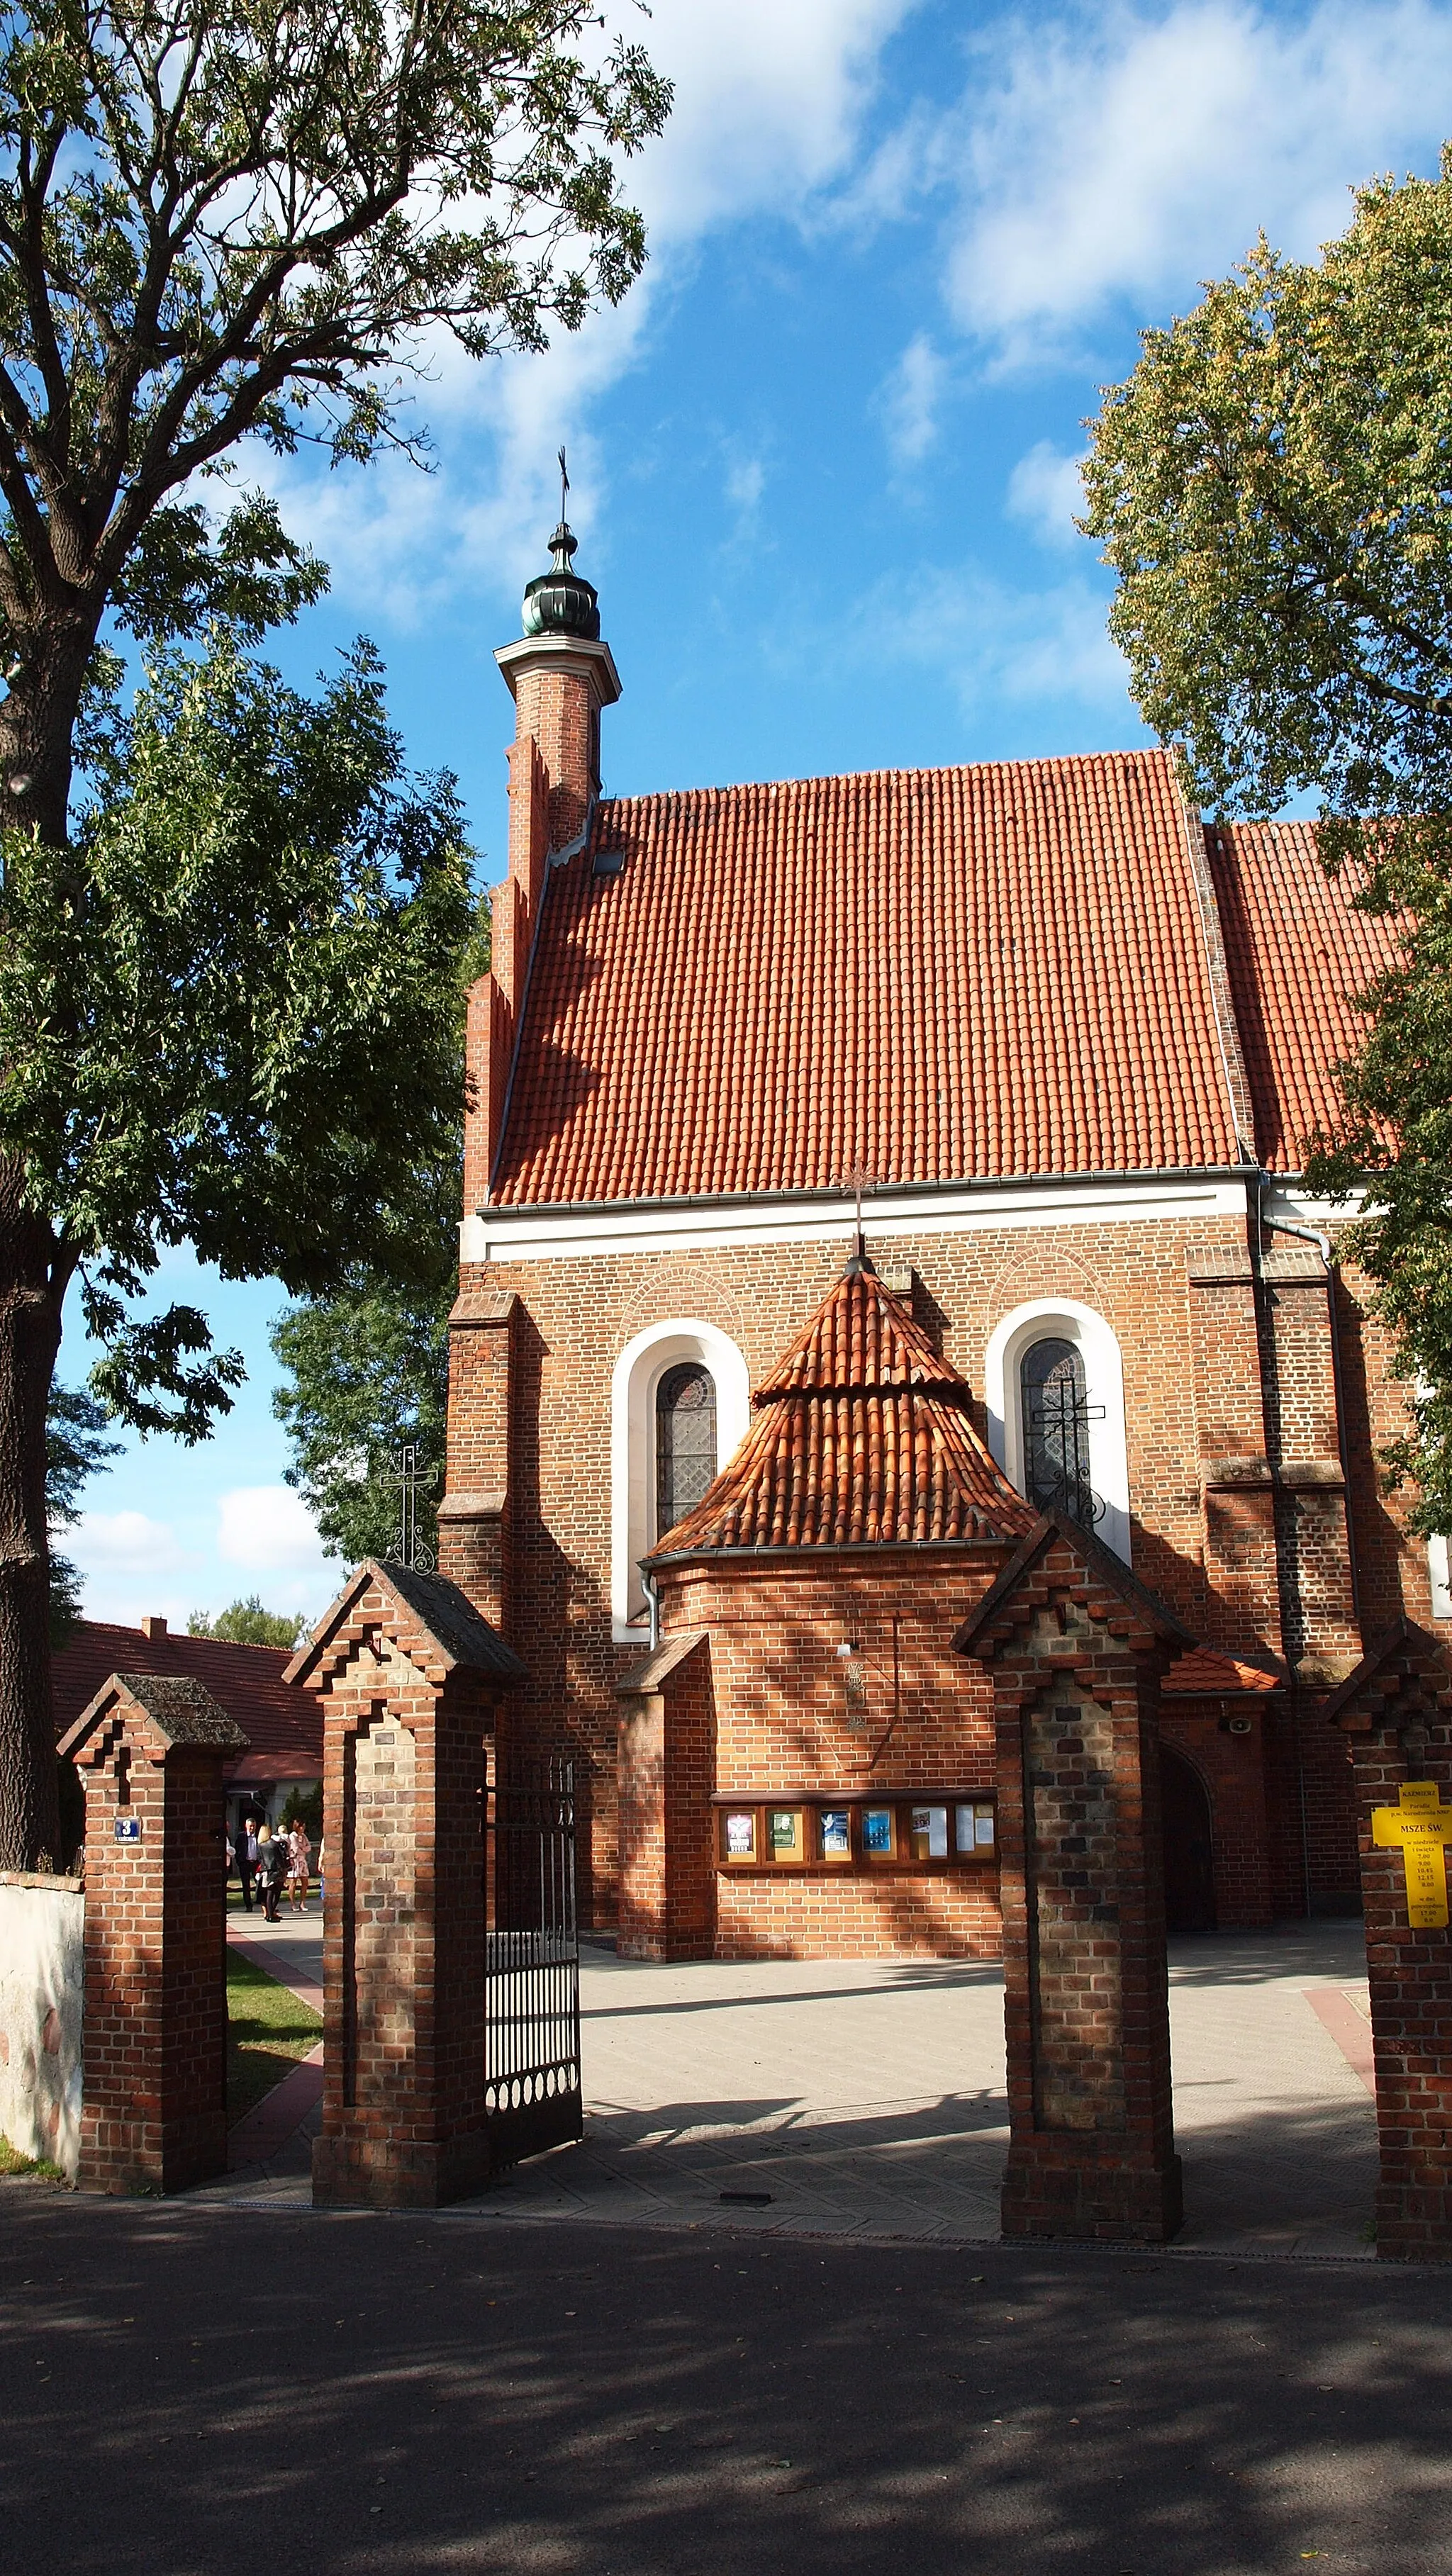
[1205,822,1398,1172]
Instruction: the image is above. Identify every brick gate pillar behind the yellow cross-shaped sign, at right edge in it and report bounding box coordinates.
[1326,1618,1452,2262]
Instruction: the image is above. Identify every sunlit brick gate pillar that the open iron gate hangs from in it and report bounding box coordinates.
[289,1561,525,2207]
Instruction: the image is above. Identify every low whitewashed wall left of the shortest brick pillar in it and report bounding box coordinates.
[0,1870,85,2182]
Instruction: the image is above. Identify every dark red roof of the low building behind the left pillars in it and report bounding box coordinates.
[52,1618,322,1780]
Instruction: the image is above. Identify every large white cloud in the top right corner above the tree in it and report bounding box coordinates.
[916,0,1452,361]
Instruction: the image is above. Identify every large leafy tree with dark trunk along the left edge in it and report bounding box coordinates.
[0,0,669,1865]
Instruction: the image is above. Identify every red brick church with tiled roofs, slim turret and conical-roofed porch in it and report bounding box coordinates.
[440,525,1452,1958]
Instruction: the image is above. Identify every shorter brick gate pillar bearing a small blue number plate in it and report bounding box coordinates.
[60,1671,247,2193]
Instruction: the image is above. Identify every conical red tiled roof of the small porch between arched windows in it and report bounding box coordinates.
[654,1262,1037,1561]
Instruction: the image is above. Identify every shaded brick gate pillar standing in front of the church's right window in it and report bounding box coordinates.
[955,1515,1190,2241]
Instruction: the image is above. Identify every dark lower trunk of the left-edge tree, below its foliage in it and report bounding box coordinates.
[0,1162,60,1870]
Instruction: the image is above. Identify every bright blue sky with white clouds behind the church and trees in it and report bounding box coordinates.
[62,0,1452,1623]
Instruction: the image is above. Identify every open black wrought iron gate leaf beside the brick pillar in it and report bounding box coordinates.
[484,1762,584,2169]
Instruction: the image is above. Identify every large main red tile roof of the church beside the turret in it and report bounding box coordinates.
[492,752,1241,1206]
